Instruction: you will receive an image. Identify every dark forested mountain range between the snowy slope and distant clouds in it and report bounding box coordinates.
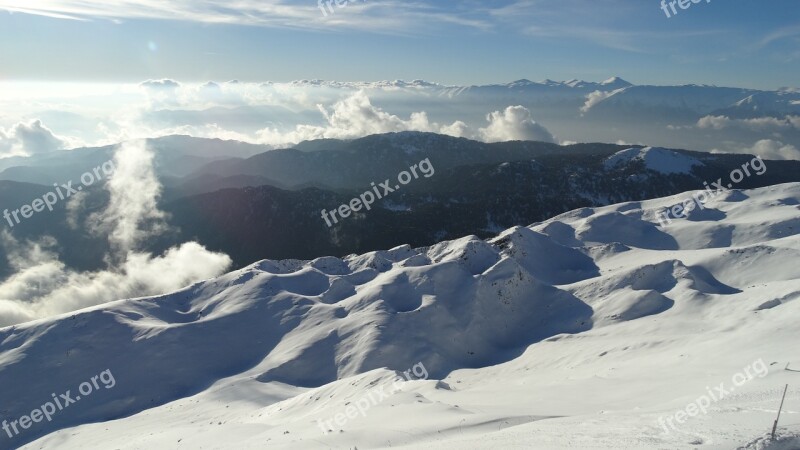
[6,132,800,274]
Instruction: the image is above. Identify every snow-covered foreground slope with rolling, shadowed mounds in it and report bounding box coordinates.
[0,184,800,449]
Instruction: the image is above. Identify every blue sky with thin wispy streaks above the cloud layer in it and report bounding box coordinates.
[0,0,800,89]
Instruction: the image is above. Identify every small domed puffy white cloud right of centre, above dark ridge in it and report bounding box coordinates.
[478,106,556,142]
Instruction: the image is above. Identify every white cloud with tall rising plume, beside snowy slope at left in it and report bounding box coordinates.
[0,143,231,326]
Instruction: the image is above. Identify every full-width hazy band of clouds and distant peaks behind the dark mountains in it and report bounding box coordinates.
[0,78,800,157]
